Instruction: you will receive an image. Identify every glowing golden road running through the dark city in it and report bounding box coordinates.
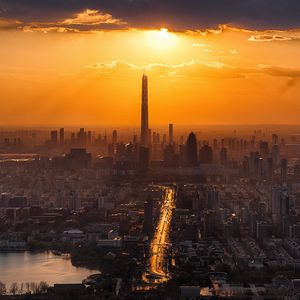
[143,187,175,284]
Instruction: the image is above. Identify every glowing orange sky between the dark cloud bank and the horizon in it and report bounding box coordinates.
[0,20,300,126]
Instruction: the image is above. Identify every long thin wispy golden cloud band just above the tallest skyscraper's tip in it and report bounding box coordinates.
[84,60,300,85]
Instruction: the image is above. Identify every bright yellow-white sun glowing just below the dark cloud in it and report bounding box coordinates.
[147,28,177,50]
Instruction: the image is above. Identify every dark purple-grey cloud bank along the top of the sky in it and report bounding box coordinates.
[0,0,300,30]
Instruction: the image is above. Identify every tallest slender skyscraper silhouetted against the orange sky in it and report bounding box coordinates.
[141,74,149,147]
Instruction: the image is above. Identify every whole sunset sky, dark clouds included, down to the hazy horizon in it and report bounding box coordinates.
[0,0,300,127]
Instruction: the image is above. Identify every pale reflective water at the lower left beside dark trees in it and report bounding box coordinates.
[0,252,99,287]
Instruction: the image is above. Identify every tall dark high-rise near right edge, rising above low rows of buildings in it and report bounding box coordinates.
[271,185,290,224]
